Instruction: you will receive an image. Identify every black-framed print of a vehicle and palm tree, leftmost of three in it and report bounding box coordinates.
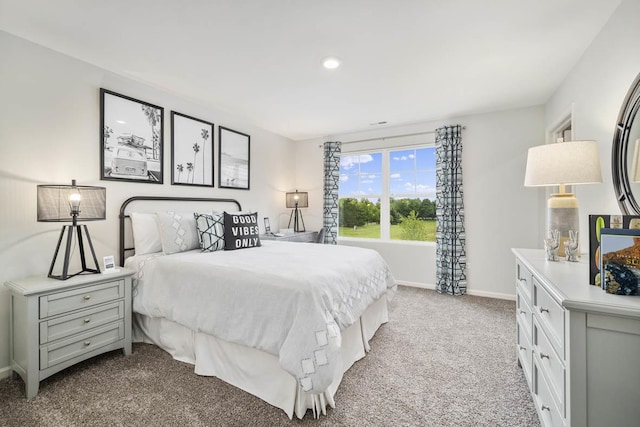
[100,89,164,184]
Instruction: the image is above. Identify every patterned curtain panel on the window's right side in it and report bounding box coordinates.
[436,125,467,295]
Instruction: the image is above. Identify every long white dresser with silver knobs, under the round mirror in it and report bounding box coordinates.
[513,249,640,427]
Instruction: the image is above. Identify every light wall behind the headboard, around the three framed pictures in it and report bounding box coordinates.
[0,32,295,377]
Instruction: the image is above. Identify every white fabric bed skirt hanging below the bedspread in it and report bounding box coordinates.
[133,296,388,419]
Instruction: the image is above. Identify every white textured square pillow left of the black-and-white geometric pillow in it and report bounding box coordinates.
[156,212,200,255]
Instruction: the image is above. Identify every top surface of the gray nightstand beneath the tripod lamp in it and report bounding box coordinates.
[5,267,133,295]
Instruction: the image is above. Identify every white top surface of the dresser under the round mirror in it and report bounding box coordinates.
[512,249,640,318]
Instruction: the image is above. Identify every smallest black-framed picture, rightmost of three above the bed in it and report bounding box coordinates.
[218,126,251,190]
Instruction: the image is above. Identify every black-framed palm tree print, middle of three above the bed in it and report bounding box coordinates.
[171,111,214,187]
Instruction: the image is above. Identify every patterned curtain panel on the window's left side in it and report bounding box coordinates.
[323,141,342,245]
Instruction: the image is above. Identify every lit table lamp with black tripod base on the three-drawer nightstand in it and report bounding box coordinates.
[37,179,107,280]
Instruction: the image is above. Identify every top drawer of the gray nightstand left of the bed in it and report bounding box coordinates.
[40,280,124,319]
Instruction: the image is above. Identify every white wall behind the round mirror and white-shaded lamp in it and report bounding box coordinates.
[546,0,640,244]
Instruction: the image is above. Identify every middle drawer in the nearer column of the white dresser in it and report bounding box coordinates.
[533,319,566,415]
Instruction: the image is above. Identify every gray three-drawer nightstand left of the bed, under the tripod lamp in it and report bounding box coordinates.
[5,268,133,399]
